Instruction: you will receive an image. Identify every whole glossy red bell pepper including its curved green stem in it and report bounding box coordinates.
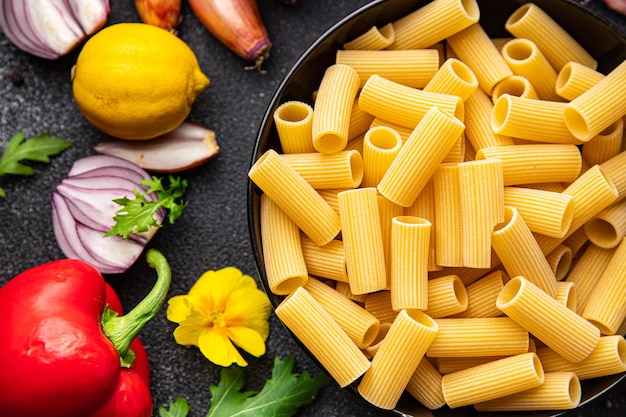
[0,249,171,417]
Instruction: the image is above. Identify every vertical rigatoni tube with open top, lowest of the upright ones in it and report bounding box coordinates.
[391,216,432,310]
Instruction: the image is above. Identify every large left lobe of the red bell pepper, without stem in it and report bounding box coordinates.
[0,259,120,417]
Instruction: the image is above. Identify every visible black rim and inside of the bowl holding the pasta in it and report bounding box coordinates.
[246,0,626,417]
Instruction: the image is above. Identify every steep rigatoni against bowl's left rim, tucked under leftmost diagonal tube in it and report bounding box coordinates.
[260,194,308,295]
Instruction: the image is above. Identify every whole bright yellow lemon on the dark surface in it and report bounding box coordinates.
[72,23,209,139]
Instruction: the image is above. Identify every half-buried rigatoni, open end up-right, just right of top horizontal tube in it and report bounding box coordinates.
[423,58,478,100]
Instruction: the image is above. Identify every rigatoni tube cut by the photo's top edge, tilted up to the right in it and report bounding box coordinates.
[389,0,480,49]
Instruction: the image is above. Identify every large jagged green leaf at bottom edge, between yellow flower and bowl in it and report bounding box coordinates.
[207,356,328,417]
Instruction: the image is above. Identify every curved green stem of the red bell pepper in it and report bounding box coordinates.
[102,249,172,361]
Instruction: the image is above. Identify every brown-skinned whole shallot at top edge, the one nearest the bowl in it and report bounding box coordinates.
[189,0,272,69]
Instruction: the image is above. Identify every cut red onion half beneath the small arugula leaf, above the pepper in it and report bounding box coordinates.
[51,155,165,274]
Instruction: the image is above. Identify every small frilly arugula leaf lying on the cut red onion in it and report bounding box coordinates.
[104,175,187,239]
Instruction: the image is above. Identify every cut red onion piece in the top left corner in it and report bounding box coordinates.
[0,0,110,59]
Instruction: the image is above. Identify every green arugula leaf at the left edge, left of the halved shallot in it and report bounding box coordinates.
[0,132,71,198]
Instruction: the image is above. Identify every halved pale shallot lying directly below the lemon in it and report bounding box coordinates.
[94,122,220,173]
